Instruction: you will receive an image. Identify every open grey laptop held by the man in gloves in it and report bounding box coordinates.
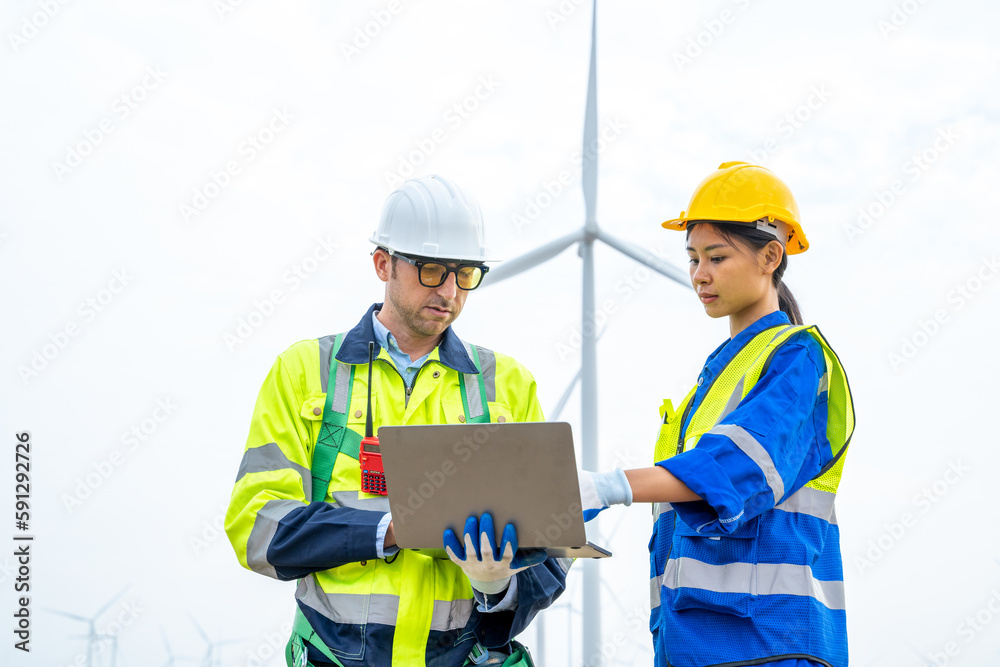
[378,422,611,558]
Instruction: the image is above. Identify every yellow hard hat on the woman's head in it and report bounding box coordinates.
[663,162,809,255]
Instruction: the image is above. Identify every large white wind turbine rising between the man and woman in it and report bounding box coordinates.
[489,0,691,665]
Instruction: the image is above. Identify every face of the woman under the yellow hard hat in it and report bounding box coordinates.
[687,223,782,335]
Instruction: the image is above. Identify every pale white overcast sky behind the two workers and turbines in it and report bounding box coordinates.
[0,0,1000,667]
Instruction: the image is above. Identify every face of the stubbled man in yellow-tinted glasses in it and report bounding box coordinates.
[374,250,469,338]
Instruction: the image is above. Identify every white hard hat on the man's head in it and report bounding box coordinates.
[371,176,490,262]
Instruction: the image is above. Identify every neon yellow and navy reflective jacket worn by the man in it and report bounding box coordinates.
[226,304,565,666]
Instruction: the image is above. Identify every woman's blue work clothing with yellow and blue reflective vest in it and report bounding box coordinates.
[650,312,854,667]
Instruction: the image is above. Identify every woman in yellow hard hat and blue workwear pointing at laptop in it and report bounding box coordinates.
[581,162,854,667]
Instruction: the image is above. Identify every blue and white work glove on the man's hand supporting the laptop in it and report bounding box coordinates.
[444,512,547,595]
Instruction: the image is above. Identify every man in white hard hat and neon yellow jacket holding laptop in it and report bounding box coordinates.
[226,176,566,667]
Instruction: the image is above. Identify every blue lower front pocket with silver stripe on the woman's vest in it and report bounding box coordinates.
[664,517,759,618]
